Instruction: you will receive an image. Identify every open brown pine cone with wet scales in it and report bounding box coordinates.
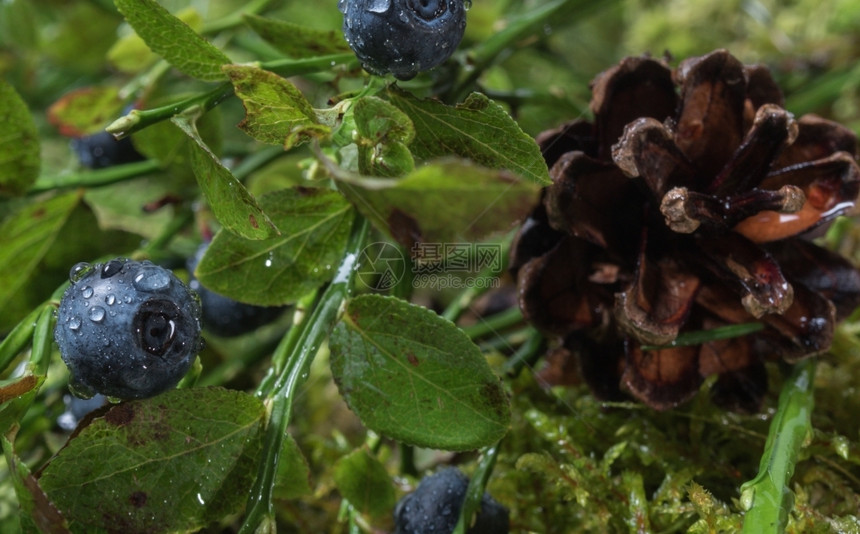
[511,50,860,412]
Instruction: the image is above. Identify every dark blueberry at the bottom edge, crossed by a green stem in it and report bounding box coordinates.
[394,467,510,534]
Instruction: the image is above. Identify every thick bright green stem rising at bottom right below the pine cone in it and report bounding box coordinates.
[741,358,816,534]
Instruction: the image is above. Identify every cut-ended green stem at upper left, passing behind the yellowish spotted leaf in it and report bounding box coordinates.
[106,53,357,139]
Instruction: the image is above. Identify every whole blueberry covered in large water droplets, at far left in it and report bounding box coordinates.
[54,258,202,399]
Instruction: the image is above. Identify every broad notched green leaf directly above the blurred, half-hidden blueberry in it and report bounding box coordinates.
[196,187,353,306]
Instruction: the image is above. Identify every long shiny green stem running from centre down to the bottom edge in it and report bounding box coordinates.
[239,218,368,534]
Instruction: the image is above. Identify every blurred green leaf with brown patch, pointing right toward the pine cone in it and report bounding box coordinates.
[336,159,538,248]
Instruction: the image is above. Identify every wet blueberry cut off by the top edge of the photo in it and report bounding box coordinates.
[337,0,466,80]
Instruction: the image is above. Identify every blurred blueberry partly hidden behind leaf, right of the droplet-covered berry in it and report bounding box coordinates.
[187,243,284,337]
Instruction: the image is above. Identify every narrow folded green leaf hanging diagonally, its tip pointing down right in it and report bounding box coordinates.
[171,117,278,239]
